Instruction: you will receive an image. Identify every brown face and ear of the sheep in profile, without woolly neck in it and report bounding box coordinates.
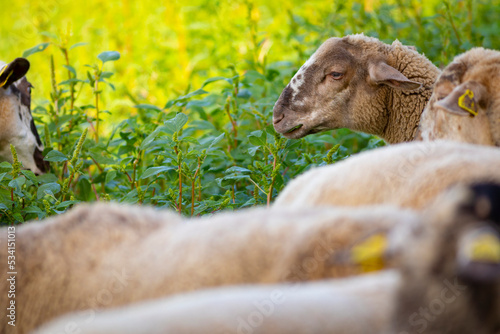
[273,35,421,138]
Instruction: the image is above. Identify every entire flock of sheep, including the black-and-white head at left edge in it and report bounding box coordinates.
[0,34,500,334]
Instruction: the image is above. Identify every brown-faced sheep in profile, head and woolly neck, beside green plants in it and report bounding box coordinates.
[273,34,440,144]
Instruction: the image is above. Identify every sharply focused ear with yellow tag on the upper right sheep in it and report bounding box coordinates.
[434,81,488,117]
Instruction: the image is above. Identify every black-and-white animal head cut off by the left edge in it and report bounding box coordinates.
[0,58,49,174]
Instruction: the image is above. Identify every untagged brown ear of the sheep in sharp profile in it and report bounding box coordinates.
[368,62,422,90]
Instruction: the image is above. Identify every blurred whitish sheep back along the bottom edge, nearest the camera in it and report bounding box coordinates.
[33,270,399,334]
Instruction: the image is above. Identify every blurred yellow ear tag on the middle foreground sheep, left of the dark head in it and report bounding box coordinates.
[351,234,387,273]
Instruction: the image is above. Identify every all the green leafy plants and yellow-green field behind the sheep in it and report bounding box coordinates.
[0,0,500,224]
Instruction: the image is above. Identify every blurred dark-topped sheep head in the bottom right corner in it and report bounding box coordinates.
[394,184,500,334]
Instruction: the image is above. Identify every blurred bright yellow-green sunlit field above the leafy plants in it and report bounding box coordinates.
[0,0,500,126]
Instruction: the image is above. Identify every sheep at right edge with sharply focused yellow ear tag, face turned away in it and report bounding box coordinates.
[417,48,500,146]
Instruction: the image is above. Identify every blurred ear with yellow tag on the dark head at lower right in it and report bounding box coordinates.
[457,225,500,283]
